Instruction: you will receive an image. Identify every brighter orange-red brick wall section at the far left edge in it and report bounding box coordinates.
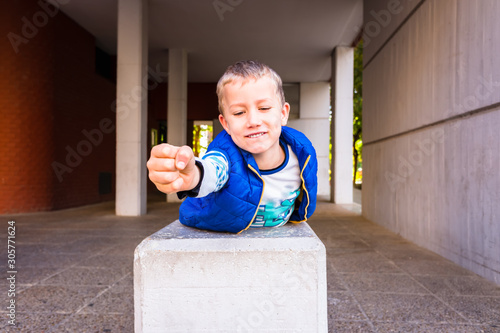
[0,1,54,213]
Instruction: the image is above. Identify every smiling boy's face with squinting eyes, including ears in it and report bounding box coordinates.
[219,76,290,162]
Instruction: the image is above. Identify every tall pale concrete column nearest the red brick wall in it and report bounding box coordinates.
[116,0,148,216]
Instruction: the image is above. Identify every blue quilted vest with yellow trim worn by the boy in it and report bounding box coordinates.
[179,127,318,233]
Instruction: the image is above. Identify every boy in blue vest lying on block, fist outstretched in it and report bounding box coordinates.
[148,61,317,233]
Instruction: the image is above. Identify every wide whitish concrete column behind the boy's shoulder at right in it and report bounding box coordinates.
[288,82,330,200]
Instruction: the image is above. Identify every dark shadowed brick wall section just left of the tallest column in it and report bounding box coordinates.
[53,15,116,209]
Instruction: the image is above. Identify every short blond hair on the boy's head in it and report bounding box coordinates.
[217,60,285,115]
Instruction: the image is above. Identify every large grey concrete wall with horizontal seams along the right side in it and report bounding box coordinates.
[363,0,500,283]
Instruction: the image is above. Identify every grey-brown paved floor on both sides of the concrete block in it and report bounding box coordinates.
[0,197,500,333]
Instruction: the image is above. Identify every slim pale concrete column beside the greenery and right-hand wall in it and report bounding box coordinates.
[331,46,354,204]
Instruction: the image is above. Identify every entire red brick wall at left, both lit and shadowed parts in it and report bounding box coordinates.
[0,1,115,214]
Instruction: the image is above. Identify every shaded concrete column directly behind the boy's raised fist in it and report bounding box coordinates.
[167,49,187,202]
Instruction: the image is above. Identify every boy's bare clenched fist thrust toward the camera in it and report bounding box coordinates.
[147,143,200,194]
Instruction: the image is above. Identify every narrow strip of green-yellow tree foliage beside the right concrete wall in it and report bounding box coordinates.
[352,40,363,185]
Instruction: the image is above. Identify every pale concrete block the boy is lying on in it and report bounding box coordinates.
[134,221,328,333]
